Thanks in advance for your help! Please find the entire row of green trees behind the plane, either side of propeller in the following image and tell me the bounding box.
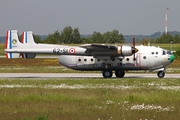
[27,26,180,44]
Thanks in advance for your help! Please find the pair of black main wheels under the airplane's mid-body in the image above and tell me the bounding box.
[102,70,125,78]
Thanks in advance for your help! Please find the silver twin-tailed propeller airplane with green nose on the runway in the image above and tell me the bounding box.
[4,30,175,78]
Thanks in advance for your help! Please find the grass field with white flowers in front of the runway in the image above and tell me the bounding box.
[0,78,180,120]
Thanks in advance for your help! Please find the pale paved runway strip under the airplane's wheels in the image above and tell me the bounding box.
[0,73,180,79]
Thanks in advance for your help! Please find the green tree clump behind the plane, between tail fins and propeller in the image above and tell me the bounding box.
[26,26,125,44]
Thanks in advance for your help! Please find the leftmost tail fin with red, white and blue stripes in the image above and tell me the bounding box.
[5,30,22,59]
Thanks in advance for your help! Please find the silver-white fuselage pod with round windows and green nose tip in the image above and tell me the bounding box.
[59,46,174,71]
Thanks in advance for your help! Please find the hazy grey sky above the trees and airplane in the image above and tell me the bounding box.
[0,0,180,36]
